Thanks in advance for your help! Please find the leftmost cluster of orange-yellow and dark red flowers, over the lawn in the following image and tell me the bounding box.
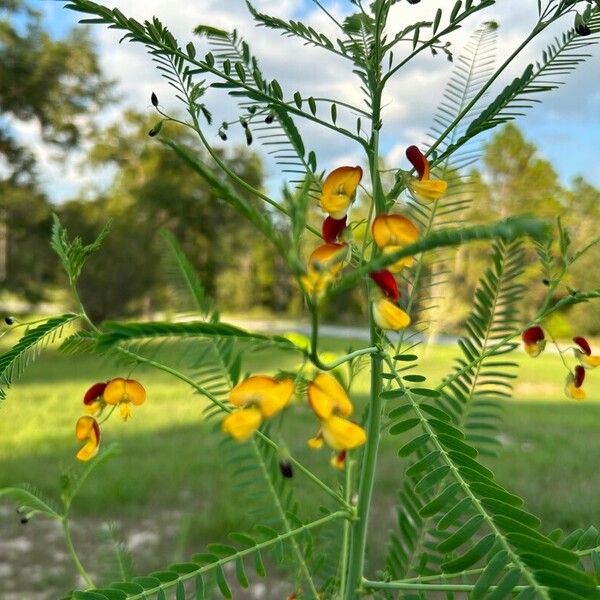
[75,377,146,461]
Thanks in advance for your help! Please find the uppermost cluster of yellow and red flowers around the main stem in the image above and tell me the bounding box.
[300,146,448,331]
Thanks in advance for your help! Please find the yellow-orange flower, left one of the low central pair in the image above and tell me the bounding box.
[222,375,294,442]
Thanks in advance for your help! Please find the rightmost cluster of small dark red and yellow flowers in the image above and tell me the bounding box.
[521,325,600,400]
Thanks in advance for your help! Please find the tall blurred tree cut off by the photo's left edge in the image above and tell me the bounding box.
[0,0,111,301]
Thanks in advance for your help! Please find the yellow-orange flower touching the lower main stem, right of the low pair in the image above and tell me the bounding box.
[308,373,367,468]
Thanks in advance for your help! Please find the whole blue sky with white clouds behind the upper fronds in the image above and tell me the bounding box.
[12,0,600,202]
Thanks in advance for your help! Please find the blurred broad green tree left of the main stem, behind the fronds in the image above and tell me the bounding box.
[60,112,293,317]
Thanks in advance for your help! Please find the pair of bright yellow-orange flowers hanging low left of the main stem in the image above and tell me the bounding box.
[222,373,367,468]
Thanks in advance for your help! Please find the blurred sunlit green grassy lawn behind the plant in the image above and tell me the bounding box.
[0,341,600,600]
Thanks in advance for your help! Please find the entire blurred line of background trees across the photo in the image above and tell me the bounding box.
[0,0,600,335]
